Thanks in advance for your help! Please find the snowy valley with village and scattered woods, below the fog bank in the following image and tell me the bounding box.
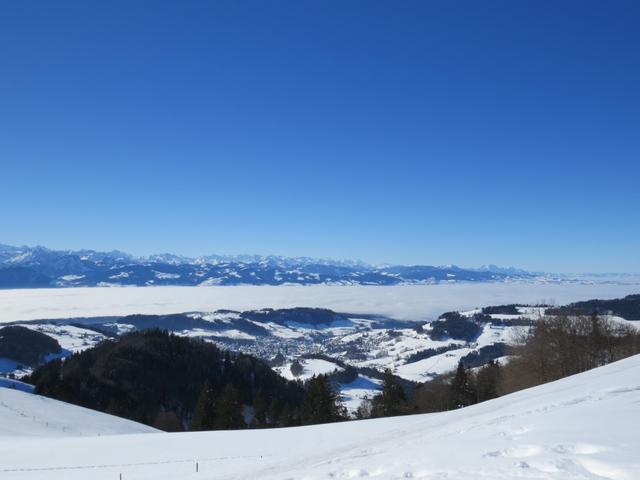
[0,296,640,412]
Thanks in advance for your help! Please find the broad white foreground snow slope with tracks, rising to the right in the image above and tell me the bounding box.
[0,356,640,480]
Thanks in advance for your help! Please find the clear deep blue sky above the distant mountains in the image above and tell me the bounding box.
[0,0,640,272]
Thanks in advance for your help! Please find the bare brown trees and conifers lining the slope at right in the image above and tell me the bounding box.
[357,315,640,418]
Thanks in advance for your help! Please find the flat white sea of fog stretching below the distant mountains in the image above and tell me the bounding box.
[0,282,640,322]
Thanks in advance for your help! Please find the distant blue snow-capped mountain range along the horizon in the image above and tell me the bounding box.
[0,245,539,288]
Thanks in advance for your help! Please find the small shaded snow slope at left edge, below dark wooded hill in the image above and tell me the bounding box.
[0,388,157,436]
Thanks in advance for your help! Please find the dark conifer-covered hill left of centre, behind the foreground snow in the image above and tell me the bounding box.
[28,330,347,431]
